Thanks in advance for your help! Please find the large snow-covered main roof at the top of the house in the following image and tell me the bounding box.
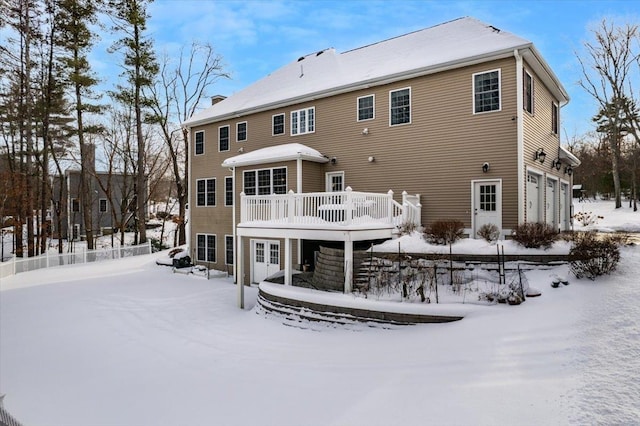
[183,17,568,127]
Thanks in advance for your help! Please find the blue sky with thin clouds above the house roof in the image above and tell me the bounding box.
[110,0,640,139]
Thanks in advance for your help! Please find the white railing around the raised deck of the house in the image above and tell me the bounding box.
[240,187,420,228]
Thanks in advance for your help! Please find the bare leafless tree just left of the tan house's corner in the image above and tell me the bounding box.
[149,42,229,245]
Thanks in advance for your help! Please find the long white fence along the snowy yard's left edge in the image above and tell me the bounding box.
[0,242,151,278]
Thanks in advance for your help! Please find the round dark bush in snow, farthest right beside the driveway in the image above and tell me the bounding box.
[569,232,621,280]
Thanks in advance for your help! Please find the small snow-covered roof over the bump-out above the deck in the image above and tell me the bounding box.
[222,143,329,167]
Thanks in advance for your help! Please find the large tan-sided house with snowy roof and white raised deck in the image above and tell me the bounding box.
[184,17,580,305]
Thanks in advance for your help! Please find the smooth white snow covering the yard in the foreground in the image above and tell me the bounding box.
[0,202,640,426]
